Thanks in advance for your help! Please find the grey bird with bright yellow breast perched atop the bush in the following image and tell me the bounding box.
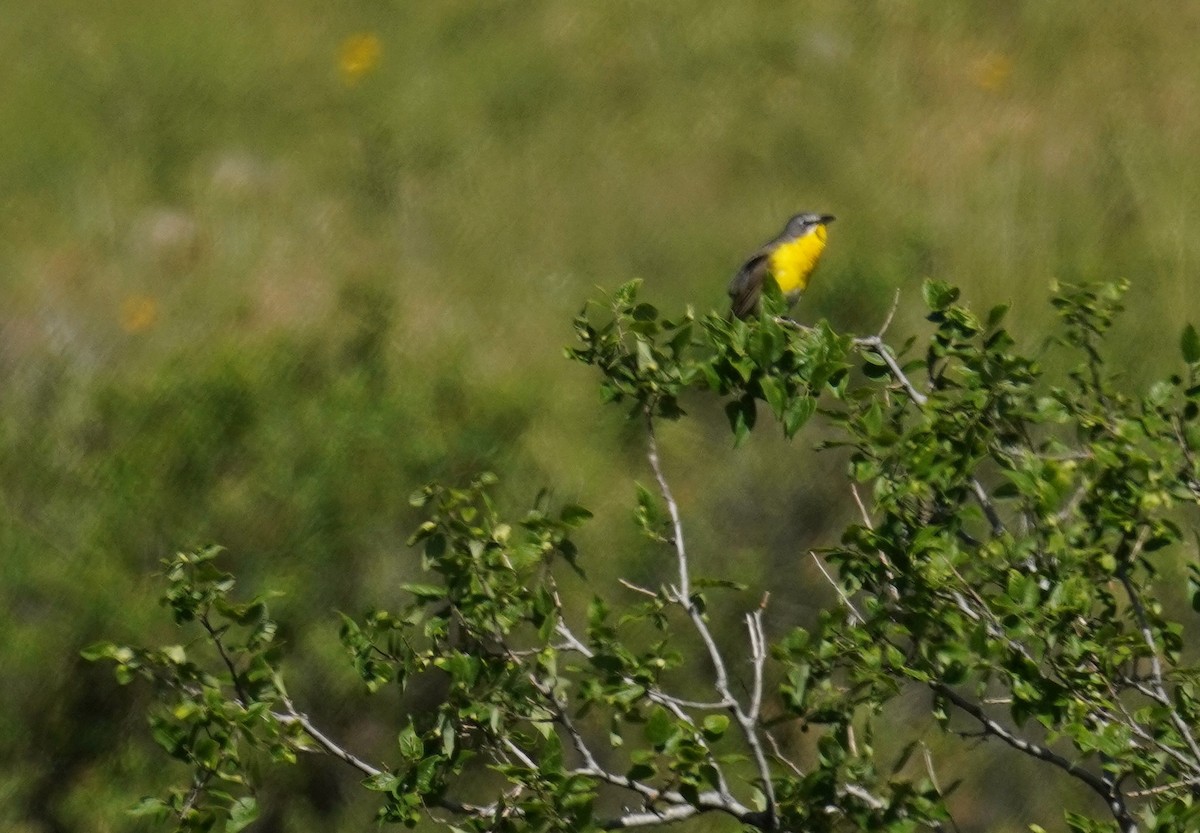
[730,214,834,318]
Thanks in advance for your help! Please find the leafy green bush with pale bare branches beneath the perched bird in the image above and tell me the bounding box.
[85,282,1200,833]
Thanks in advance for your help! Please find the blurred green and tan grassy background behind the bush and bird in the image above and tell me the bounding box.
[0,0,1200,833]
